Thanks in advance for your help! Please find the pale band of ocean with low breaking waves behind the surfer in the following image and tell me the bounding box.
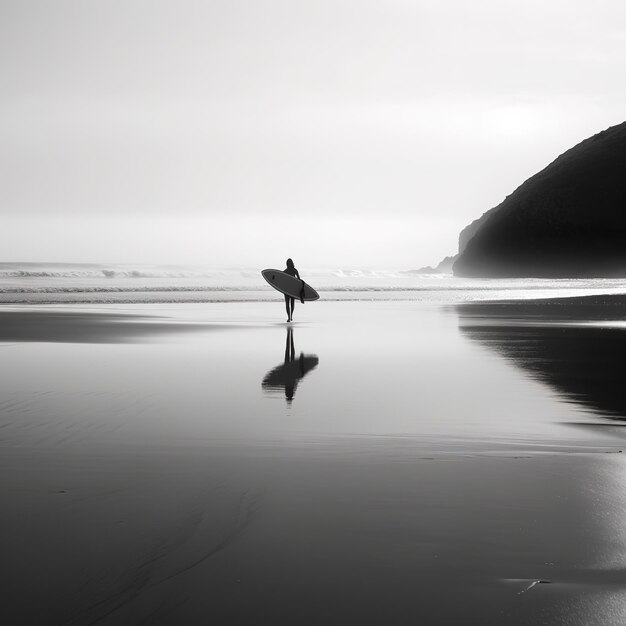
[0,263,626,304]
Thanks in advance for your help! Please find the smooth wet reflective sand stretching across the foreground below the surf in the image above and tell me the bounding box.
[0,297,626,625]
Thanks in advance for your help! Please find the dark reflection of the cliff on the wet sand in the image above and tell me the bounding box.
[456,296,626,420]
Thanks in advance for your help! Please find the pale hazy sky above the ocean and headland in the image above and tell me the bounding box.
[0,0,626,267]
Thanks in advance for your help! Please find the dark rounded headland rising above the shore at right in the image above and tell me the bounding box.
[453,122,626,278]
